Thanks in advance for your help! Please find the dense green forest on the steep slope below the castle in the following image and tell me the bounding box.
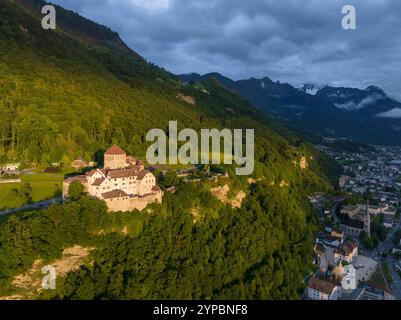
[0,178,324,299]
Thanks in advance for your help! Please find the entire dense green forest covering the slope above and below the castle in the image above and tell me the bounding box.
[0,0,338,299]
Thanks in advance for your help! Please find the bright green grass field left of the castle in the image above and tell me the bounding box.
[0,174,63,210]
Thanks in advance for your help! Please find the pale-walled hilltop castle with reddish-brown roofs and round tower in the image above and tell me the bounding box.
[63,145,163,212]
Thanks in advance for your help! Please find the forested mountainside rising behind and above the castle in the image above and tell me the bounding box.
[0,1,282,163]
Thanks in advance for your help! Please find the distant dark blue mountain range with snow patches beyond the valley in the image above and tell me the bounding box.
[180,73,401,145]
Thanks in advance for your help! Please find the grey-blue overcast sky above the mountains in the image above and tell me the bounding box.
[51,0,401,100]
